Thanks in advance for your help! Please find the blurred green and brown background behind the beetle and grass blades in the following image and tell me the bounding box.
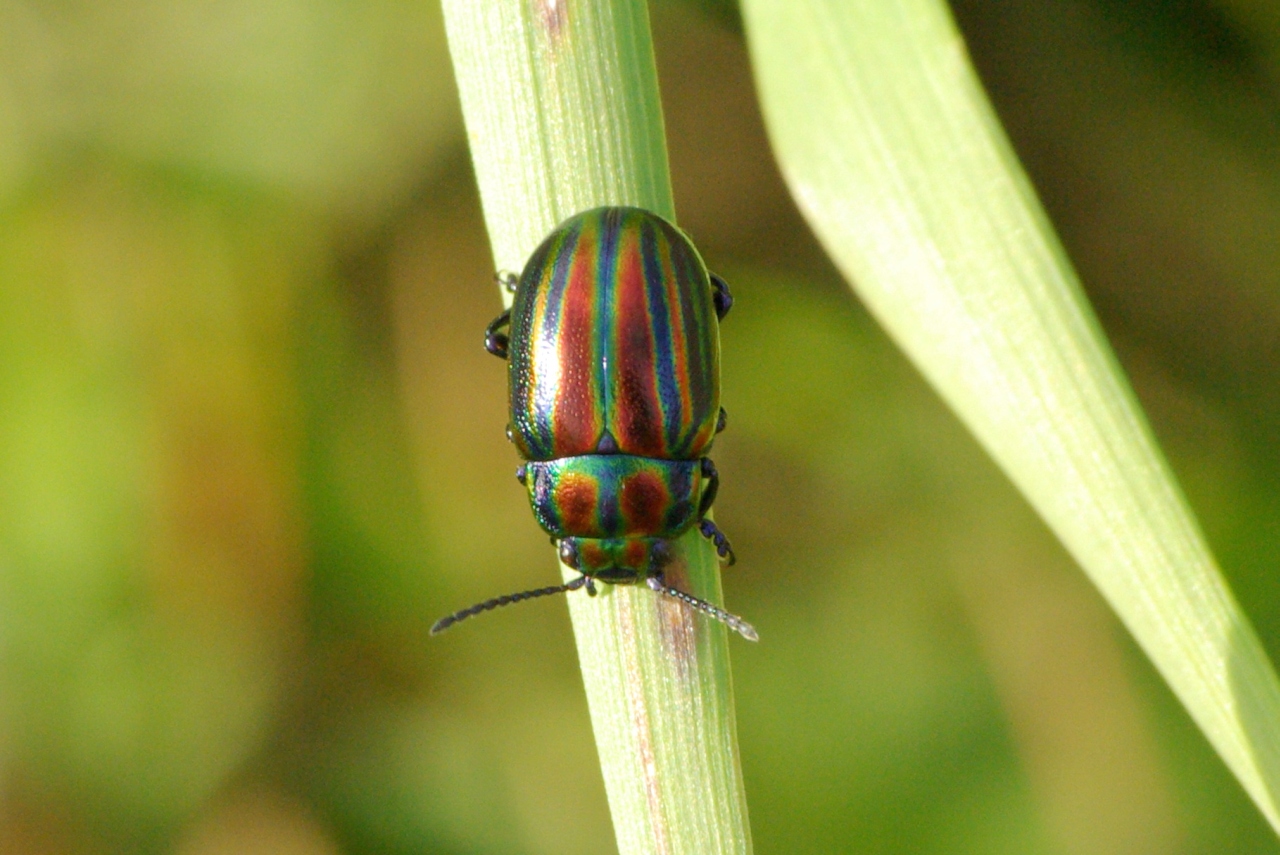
[0,0,1280,855]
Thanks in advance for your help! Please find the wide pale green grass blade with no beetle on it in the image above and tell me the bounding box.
[742,0,1280,828]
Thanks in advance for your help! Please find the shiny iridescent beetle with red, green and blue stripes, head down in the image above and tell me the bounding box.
[431,207,756,641]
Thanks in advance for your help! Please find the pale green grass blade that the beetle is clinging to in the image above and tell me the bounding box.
[444,0,751,855]
